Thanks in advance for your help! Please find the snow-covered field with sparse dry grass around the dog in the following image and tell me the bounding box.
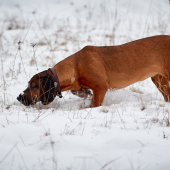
[0,0,170,170]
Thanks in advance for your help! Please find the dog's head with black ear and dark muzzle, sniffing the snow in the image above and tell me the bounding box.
[17,70,62,106]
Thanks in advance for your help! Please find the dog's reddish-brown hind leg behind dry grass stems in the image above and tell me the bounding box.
[151,74,170,102]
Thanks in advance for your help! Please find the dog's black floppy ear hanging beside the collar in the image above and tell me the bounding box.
[41,73,57,105]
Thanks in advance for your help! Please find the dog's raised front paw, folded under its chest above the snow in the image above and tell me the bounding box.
[71,88,92,98]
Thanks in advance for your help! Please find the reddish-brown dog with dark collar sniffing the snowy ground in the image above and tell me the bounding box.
[17,35,170,107]
